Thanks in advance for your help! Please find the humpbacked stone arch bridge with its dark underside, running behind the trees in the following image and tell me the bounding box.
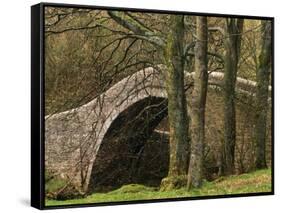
[45,67,271,192]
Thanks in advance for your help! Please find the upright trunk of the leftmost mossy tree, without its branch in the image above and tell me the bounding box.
[162,15,189,188]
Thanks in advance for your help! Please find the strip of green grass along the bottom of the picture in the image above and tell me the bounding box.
[46,169,271,206]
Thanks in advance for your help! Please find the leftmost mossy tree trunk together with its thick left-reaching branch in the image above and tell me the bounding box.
[108,11,190,188]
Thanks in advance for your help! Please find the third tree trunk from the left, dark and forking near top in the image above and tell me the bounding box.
[223,18,243,174]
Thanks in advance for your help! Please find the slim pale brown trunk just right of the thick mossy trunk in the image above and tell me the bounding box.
[187,16,208,188]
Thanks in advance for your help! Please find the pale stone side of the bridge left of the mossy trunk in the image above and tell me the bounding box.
[45,68,166,191]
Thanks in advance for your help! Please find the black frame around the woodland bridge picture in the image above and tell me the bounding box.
[31,3,275,209]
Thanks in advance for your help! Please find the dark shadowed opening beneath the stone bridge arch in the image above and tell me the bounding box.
[88,96,169,192]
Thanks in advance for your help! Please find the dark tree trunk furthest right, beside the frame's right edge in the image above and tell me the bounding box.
[255,21,271,169]
